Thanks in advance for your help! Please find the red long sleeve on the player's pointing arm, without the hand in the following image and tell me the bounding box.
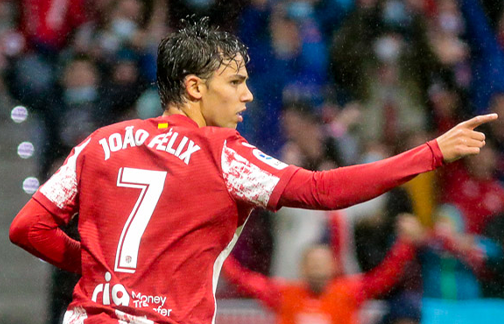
[278,140,443,210]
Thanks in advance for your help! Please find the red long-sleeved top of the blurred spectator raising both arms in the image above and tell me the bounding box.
[223,242,414,324]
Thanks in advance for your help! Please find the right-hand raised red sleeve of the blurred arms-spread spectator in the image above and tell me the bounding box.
[362,241,415,300]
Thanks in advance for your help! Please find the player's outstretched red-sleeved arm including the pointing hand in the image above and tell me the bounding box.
[277,114,497,209]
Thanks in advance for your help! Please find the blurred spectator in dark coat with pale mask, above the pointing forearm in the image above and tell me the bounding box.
[330,1,437,144]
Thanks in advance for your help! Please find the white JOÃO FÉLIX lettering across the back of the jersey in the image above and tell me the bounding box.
[98,126,200,164]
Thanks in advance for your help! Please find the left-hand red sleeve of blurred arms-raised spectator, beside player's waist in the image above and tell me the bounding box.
[222,256,282,311]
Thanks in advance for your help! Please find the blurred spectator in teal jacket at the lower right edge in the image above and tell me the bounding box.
[418,205,504,300]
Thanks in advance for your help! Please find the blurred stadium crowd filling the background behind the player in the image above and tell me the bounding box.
[0,0,504,323]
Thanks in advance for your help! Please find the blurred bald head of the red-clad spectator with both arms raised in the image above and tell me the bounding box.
[301,245,339,294]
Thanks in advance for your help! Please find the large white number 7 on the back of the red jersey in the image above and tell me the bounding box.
[114,168,167,273]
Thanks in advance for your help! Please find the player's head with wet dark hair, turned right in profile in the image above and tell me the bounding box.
[157,18,253,128]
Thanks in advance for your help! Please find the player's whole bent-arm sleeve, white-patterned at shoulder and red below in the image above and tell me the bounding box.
[9,138,91,273]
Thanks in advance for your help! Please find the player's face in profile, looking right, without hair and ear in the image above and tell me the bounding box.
[197,55,254,129]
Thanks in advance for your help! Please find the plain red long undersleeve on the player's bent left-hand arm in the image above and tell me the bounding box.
[9,199,81,273]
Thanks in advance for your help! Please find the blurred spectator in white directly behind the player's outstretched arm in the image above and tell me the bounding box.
[271,101,366,279]
